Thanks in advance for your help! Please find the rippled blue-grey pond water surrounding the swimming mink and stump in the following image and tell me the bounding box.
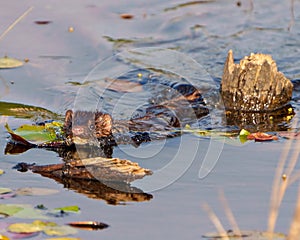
[0,0,300,239]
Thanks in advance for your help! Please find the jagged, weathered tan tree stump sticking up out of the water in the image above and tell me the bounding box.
[221,50,293,112]
